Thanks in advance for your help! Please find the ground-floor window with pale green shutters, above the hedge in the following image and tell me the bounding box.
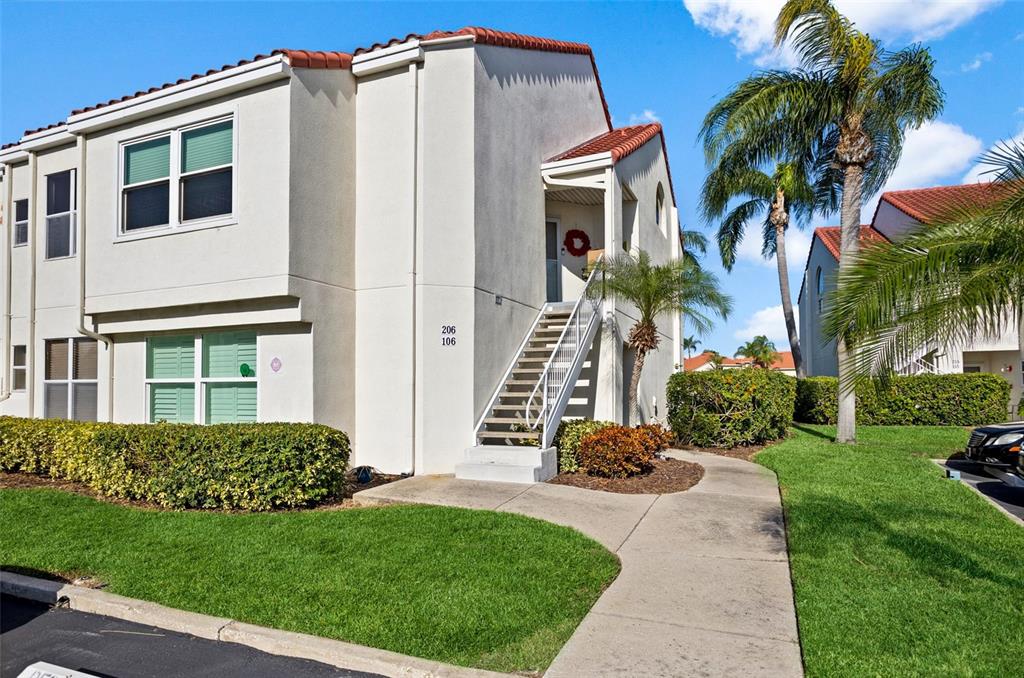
[145,331,259,424]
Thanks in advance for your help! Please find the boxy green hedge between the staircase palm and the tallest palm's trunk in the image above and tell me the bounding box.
[667,368,797,448]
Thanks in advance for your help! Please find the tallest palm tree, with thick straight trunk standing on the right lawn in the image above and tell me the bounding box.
[701,0,943,442]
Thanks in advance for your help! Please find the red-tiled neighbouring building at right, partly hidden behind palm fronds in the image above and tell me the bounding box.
[799,183,1024,407]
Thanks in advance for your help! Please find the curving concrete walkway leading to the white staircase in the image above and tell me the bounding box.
[355,451,803,678]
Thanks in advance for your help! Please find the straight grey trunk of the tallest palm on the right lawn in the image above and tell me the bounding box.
[836,164,864,442]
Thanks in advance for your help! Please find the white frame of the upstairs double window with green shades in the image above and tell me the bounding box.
[114,113,239,242]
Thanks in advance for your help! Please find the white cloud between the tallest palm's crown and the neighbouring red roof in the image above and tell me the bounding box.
[861,122,983,222]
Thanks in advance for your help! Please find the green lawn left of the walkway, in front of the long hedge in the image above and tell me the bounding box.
[0,489,618,671]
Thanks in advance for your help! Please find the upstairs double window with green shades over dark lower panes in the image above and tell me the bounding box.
[120,119,234,235]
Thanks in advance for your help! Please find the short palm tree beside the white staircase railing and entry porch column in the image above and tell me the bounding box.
[599,250,732,424]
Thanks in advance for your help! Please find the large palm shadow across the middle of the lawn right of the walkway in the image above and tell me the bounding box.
[787,495,1020,589]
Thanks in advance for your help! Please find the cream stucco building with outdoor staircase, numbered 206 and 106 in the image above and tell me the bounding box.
[0,29,680,483]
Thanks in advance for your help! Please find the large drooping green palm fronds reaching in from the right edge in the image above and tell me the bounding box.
[824,141,1024,391]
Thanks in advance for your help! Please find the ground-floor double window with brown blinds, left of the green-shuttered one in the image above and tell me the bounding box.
[43,338,97,421]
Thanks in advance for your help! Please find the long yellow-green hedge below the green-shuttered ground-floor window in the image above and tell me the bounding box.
[0,417,349,511]
